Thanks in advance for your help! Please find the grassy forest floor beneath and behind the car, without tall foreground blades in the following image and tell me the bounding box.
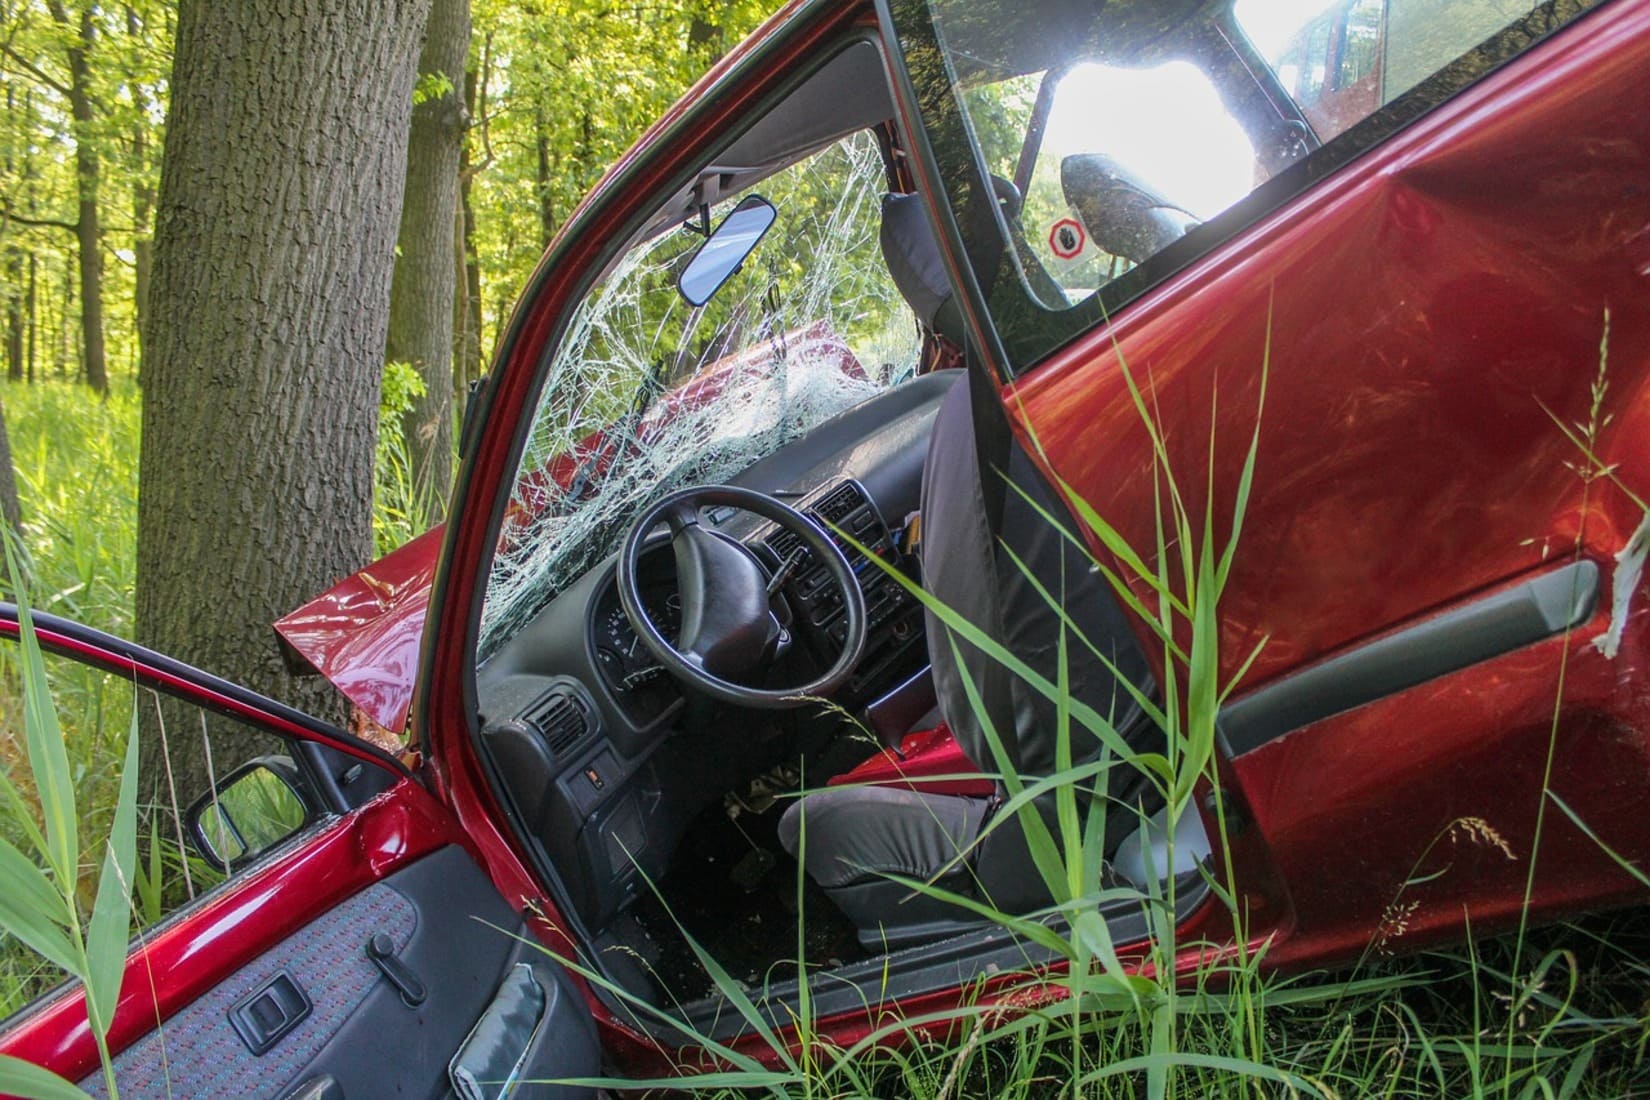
[0,374,1650,1100]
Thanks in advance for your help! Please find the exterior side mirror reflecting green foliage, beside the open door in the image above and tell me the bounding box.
[183,757,310,871]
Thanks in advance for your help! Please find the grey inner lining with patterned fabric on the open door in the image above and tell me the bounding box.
[81,846,599,1100]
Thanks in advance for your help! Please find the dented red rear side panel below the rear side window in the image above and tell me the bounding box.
[1008,5,1650,963]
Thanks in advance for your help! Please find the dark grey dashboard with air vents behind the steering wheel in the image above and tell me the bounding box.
[475,371,960,930]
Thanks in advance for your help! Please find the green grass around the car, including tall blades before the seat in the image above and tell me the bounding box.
[0,341,1650,1100]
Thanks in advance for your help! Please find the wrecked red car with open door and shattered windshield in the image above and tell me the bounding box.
[0,0,1650,1097]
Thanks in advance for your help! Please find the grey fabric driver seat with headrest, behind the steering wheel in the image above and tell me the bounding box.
[779,191,1160,950]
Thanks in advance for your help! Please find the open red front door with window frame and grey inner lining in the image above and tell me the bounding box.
[0,605,601,1097]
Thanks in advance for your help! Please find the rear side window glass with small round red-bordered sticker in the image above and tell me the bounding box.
[889,0,1592,369]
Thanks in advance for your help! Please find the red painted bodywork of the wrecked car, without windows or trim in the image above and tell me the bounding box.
[0,0,1650,1077]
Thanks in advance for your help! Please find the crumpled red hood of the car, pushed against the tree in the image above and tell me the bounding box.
[276,325,865,732]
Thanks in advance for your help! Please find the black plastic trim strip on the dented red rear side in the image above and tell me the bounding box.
[1219,561,1599,755]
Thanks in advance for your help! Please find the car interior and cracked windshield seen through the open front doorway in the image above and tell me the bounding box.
[475,25,1240,1022]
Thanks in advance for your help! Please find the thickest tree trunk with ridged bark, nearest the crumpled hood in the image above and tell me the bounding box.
[137,0,427,798]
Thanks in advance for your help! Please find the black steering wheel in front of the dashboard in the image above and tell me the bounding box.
[617,485,866,709]
